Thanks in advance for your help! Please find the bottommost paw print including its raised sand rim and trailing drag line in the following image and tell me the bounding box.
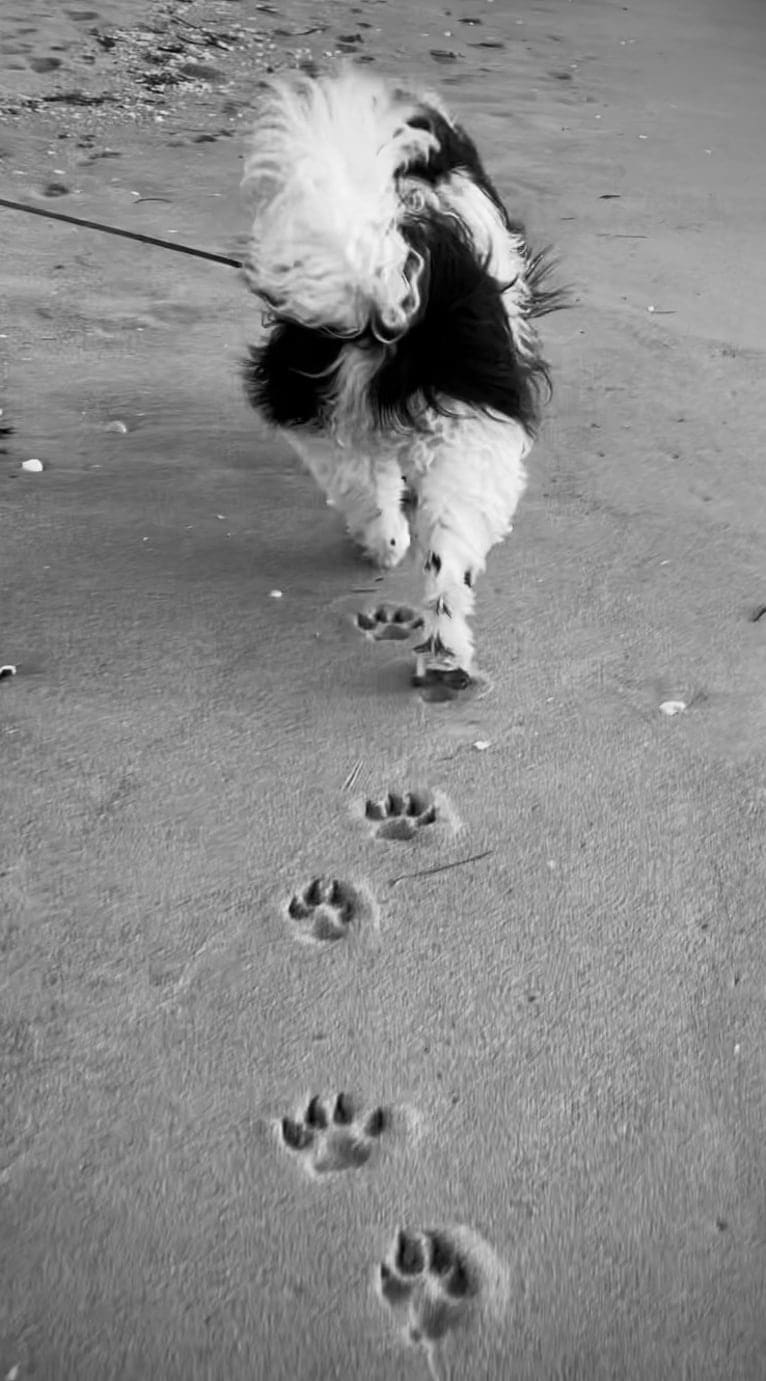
[375,1226,509,1381]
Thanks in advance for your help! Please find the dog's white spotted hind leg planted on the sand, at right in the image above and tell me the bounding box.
[415,417,530,686]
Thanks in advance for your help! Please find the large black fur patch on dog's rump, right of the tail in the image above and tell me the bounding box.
[373,214,547,431]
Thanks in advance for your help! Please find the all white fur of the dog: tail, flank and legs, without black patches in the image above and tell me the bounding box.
[243,69,549,674]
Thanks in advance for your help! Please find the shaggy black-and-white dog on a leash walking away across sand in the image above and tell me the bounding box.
[242,68,563,688]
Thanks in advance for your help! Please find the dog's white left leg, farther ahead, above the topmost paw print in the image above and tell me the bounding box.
[284,431,410,568]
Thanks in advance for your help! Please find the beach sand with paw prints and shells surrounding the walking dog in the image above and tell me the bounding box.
[0,0,766,1381]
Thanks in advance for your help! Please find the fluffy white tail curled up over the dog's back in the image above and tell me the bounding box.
[243,69,447,340]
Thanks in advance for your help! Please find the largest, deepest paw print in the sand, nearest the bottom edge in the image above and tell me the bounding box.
[378,1228,480,1346]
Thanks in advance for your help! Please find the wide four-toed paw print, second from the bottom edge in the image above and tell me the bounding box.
[279,1094,389,1175]
